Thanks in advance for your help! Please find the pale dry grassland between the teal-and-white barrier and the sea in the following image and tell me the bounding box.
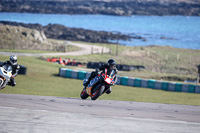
[54,42,200,82]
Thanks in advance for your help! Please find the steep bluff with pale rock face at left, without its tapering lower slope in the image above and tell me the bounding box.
[0,25,49,50]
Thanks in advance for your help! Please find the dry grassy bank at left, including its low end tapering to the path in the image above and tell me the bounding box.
[0,25,80,52]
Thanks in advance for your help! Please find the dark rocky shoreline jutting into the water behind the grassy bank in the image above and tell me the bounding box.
[0,21,145,43]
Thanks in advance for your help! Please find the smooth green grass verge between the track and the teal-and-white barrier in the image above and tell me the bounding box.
[0,55,200,106]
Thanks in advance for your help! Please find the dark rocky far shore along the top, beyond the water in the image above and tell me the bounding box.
[0,0,200,16]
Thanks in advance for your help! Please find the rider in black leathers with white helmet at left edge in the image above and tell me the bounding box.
[1,55,20,87]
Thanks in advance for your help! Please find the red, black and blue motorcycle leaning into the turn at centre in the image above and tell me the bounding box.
[80,69,116,100]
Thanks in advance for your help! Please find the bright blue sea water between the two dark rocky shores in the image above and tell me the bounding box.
[0,13,200,49]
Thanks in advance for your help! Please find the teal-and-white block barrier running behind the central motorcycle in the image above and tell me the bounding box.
[59,68,200,93]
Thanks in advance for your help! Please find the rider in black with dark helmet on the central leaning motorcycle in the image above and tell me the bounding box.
[84,59,118,94]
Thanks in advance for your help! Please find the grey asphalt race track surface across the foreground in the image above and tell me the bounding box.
[0,94,200,133]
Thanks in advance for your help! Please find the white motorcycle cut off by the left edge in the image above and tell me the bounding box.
[0,64,12,90]
